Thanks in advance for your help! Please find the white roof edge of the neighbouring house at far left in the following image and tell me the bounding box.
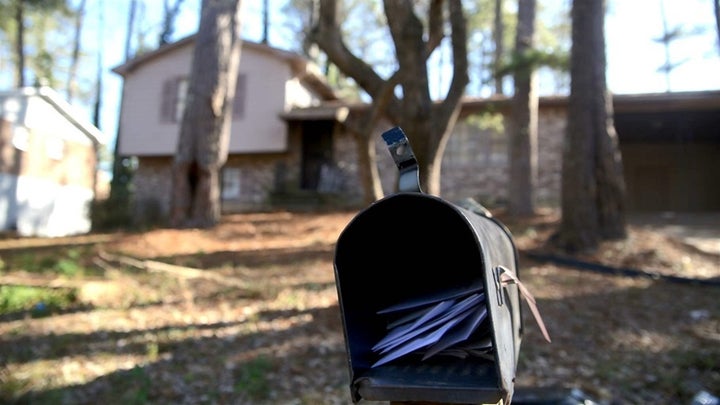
[0,86,107,145]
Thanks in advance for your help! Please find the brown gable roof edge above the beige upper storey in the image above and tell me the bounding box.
[111,34,338,100]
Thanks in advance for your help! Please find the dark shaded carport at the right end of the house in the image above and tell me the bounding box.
[613,91,720,212]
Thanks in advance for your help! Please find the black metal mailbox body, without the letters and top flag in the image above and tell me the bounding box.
[334,192,522,404]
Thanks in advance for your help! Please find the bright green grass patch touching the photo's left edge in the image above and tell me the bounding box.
[0,286,77,317]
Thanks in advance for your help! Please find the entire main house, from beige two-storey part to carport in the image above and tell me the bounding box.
[113,36,720,221]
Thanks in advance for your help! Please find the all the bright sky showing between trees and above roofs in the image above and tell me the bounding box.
[7,0,720,149]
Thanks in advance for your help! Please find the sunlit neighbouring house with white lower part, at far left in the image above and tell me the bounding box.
[0,87,105,237]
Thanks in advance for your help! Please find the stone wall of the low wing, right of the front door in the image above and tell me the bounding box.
[334,106,566,206]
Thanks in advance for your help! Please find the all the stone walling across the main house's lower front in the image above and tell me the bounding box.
[133,103,565,218]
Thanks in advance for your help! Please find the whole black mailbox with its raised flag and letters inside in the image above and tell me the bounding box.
[334,128,522,404]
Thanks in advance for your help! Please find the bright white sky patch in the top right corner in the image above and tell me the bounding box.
[605,0,720,94]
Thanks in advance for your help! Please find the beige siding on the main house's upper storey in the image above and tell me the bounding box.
[119,44,312,156]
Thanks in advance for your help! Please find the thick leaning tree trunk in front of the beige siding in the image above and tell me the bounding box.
[170,0,242,227]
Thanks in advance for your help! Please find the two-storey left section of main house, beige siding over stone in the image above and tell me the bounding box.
[113,35,337,220]
